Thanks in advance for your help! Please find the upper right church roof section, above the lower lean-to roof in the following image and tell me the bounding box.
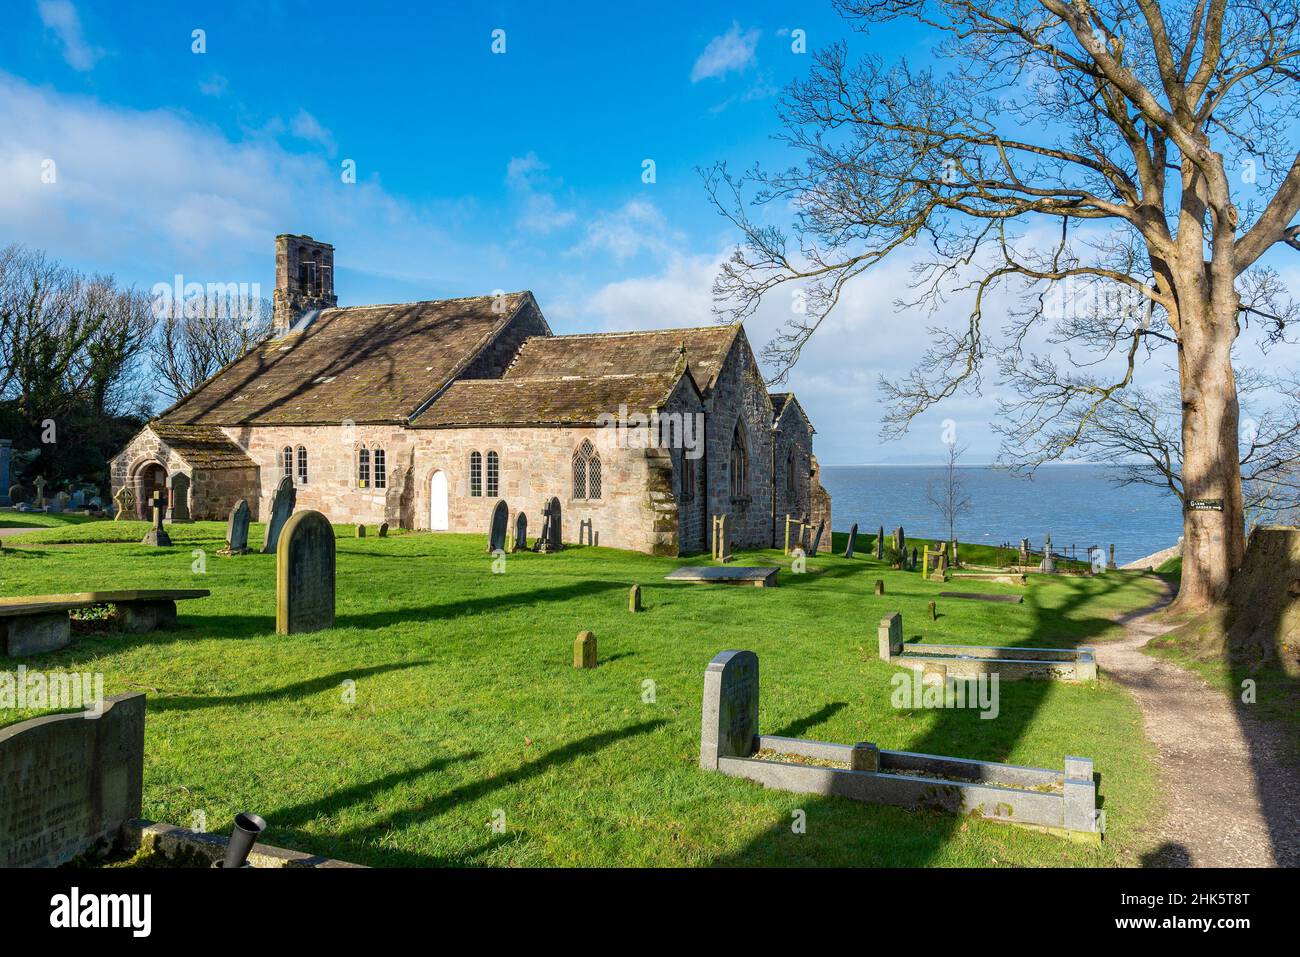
[506,325,740,395]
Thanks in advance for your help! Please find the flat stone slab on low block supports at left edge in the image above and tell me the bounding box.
[0,588,212,658]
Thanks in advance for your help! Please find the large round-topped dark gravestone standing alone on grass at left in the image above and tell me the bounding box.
[276,510,334,635]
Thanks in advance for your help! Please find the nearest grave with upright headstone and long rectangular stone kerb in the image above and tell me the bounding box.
[699,651,1104,841]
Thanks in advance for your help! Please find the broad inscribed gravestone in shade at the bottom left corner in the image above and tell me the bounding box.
[0,692,144,867]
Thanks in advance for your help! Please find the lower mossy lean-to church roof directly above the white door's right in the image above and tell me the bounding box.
[412,371,693,428]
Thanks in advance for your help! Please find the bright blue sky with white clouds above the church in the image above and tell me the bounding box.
[0,0,1294,464]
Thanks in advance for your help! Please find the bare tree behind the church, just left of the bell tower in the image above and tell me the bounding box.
[150,290,272,402]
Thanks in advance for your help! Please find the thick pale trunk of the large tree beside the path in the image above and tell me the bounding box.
[1174,295,1245,611]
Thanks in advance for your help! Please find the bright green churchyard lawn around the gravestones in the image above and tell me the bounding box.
[0,521,1158,866]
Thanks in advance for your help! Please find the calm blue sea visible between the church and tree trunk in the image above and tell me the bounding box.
[822,464,1183,564]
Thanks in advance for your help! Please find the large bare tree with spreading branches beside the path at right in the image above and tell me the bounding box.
[706,0,1300,610]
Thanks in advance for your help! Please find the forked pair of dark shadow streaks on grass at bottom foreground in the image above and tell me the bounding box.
[268,718,668,867]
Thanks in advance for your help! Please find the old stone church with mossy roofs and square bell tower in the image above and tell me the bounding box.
[113,235,831,555]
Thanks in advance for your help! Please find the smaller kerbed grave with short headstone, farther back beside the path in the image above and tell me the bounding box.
[876,611,1097,681]
